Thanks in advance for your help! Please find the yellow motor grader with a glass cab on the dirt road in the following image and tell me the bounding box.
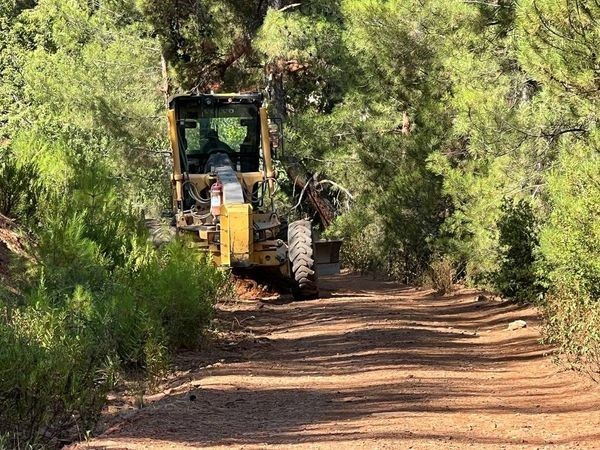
[168,93,339,299]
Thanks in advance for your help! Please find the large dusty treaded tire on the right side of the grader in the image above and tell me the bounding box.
[288,220,319,300]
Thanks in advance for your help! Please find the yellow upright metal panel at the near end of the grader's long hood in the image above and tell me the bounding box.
[220,204,253,266]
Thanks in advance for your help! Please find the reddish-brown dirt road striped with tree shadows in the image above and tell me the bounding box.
[80,275,600,449]
